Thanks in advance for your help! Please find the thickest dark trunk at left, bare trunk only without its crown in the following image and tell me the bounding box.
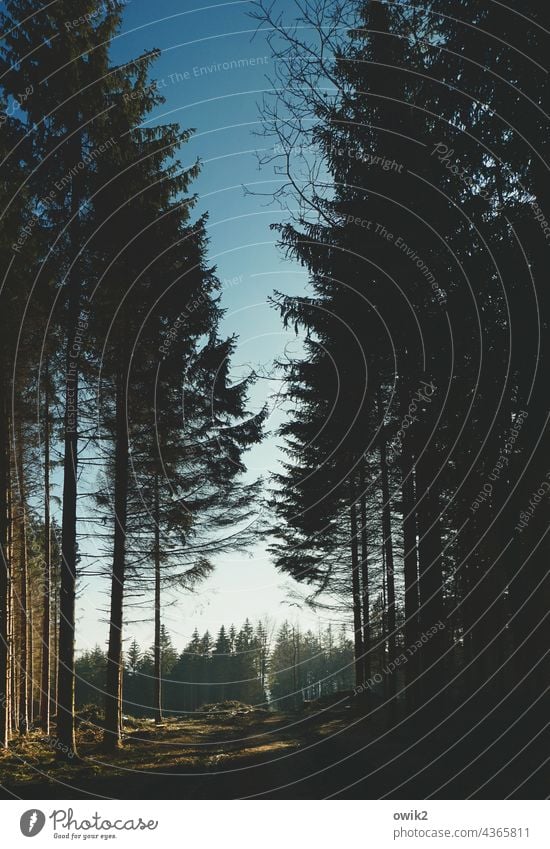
[56,144,82,758]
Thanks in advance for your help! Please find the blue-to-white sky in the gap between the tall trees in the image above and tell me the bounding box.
[73,0,340,652]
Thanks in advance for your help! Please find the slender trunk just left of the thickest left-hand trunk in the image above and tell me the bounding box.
[40,380,52,735]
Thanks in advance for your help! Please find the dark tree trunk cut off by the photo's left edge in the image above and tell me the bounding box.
[0,388,11,749]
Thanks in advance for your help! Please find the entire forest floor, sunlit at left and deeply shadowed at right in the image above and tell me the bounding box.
[0,704,550,799]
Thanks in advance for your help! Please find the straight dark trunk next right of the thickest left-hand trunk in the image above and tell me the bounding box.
[104,369,128,749]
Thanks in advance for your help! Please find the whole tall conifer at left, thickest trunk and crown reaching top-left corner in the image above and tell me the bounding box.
[2,0,131,756]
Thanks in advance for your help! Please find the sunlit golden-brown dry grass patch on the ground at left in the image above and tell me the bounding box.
[0,706,348,788]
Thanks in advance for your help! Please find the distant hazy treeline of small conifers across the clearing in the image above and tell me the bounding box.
[76,619,353,716]
